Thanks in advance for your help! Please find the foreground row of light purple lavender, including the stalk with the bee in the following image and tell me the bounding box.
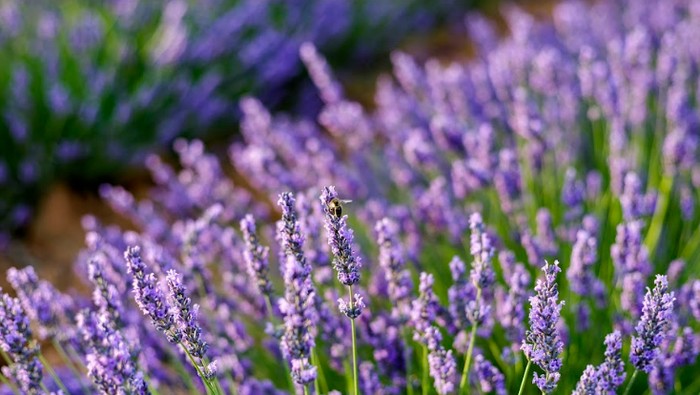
[0,0,700,395]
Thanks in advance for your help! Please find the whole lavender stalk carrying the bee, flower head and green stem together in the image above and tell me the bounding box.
[321,186,365,395]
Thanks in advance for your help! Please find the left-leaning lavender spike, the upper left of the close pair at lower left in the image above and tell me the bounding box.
[124,247,182,343]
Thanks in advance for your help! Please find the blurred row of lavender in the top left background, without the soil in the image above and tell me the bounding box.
[0,0,464,238]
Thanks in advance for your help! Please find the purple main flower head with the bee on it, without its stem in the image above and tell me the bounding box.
[321,186,362,285]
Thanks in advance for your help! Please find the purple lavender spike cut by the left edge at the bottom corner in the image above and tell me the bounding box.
[0,289,43,394]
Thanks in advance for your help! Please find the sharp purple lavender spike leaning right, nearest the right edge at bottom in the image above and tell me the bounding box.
[630,274,676,373]
